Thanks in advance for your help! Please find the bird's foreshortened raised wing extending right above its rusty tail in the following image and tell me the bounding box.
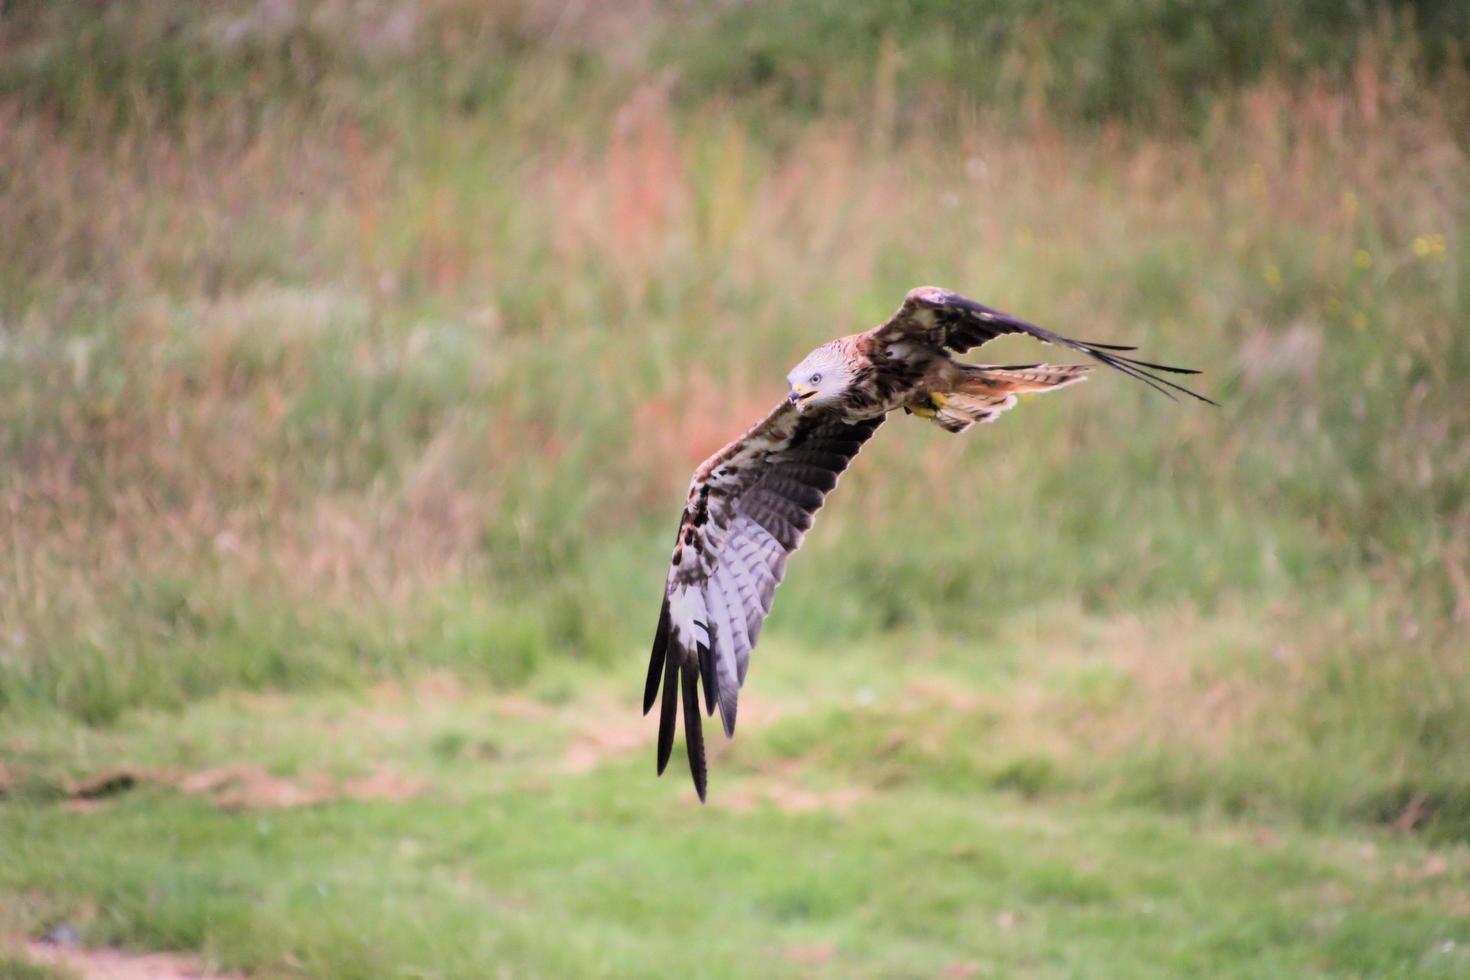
[873,287,1216,406]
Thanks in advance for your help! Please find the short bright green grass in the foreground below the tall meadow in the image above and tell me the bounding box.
[0,648,1470,977]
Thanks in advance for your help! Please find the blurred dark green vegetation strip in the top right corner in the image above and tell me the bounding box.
[663,0,1470,128]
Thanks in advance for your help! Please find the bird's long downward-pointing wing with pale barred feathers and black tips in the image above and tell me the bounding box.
[644,401,882,799]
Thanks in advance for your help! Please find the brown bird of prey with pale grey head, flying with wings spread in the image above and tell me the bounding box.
[644,287,1214,801]
